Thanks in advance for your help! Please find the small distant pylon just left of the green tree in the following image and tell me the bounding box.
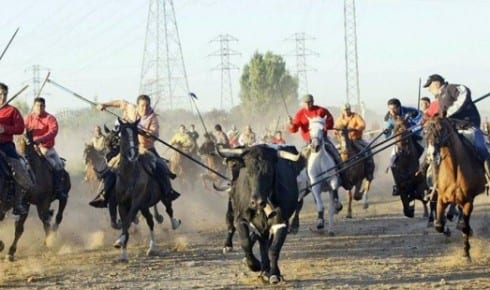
[211,34,240,110]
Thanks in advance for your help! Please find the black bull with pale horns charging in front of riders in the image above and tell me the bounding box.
[219,145,304,283]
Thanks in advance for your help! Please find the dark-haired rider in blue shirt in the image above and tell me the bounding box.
[383,98,424,196]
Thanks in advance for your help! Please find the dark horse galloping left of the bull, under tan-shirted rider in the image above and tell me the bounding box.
[114,120,174,262]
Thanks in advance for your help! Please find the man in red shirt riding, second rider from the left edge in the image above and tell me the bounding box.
[24,97,68,199]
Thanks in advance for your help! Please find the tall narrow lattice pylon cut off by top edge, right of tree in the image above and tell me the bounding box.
[344,0,364,115]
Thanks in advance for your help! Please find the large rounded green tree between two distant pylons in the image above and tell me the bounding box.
[240,51,298,114]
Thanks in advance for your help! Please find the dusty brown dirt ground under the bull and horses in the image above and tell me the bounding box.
[0,174,490,289]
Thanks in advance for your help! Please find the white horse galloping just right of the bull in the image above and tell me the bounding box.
[306,117,340,235]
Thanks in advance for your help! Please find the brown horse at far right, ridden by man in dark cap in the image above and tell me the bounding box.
[424,118,486,261]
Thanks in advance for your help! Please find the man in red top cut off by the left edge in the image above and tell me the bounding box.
[0,83,33,215]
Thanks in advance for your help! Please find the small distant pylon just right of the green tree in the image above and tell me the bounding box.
[286,32,318,95]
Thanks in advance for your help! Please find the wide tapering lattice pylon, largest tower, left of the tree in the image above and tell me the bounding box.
[140,0,192,109]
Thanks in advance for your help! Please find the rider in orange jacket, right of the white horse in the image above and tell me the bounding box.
[334,104,374,187]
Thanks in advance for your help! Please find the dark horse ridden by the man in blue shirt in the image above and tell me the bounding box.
[391,118,429,218]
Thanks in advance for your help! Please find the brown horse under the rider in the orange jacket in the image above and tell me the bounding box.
[337,128,374,218]
